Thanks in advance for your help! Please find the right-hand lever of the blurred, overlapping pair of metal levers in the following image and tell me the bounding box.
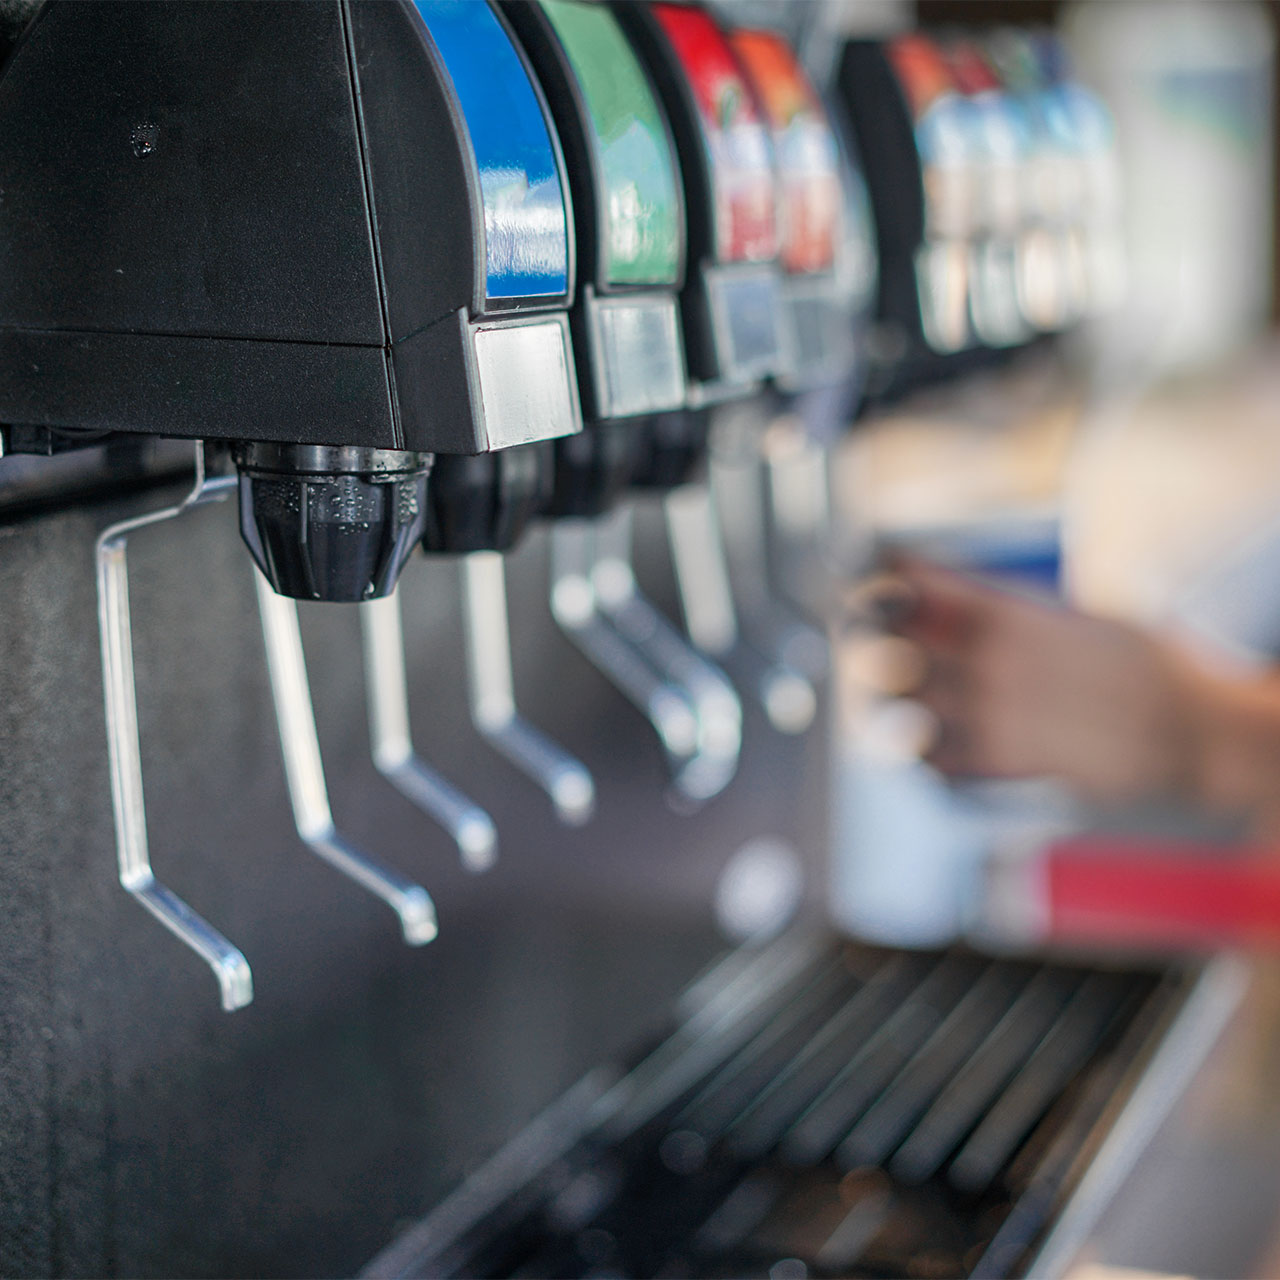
[590,507,742,801]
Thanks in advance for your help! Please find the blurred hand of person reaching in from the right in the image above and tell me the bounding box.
[860,561,1207,801]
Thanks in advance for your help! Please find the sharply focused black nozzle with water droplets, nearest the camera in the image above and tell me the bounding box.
[236,440,431,603]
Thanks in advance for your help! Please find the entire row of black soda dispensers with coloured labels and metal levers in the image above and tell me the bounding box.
[0,0,1120,1010]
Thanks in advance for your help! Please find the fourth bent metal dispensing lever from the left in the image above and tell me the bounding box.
[462,552,595,826]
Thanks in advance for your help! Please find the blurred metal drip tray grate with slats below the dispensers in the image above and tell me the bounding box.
[366,940,1194,1280]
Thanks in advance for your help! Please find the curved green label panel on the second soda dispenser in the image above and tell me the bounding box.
[541,0,682,284]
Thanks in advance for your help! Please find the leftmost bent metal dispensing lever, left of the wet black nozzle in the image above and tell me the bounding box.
[96,440,253,1012]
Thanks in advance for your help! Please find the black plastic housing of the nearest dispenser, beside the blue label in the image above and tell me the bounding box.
[0,0,567,453]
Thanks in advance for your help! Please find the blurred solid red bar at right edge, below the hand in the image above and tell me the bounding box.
[1041,838,1280,947]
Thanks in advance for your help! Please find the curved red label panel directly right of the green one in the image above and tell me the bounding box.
[653,4,778,262]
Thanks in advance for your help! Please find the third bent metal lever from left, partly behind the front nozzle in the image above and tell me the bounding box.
[360,591,498,872]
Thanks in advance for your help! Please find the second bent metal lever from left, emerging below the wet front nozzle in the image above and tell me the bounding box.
[253,571,436,946]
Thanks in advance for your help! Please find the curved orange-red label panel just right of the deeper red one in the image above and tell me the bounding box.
[730,31,844,273]
